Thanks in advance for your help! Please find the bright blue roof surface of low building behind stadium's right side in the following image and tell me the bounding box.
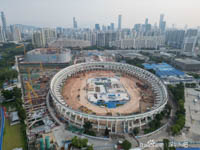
[143,63,185,77]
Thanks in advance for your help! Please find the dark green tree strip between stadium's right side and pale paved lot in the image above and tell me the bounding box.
[168,83,185,135]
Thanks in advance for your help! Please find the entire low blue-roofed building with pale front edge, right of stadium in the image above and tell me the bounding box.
[143,62,195,84]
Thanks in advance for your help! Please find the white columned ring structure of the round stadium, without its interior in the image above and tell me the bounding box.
[49,62,168,133]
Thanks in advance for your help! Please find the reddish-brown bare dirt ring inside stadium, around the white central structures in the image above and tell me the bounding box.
[62,71,153,116]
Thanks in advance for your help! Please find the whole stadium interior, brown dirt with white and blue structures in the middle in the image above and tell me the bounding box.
[62,71,154,116]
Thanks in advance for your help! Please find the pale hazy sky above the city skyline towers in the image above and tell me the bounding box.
[0,0,200,27]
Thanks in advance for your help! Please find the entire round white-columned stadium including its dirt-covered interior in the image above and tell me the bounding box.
[49,62,168,133]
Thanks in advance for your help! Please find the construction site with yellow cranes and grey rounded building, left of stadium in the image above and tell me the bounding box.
[17,48,71,148]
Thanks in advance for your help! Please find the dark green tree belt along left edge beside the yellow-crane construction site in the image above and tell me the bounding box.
[0,43,33,148]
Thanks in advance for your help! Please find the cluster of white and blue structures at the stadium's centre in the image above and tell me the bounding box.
[86,76,130,108]
